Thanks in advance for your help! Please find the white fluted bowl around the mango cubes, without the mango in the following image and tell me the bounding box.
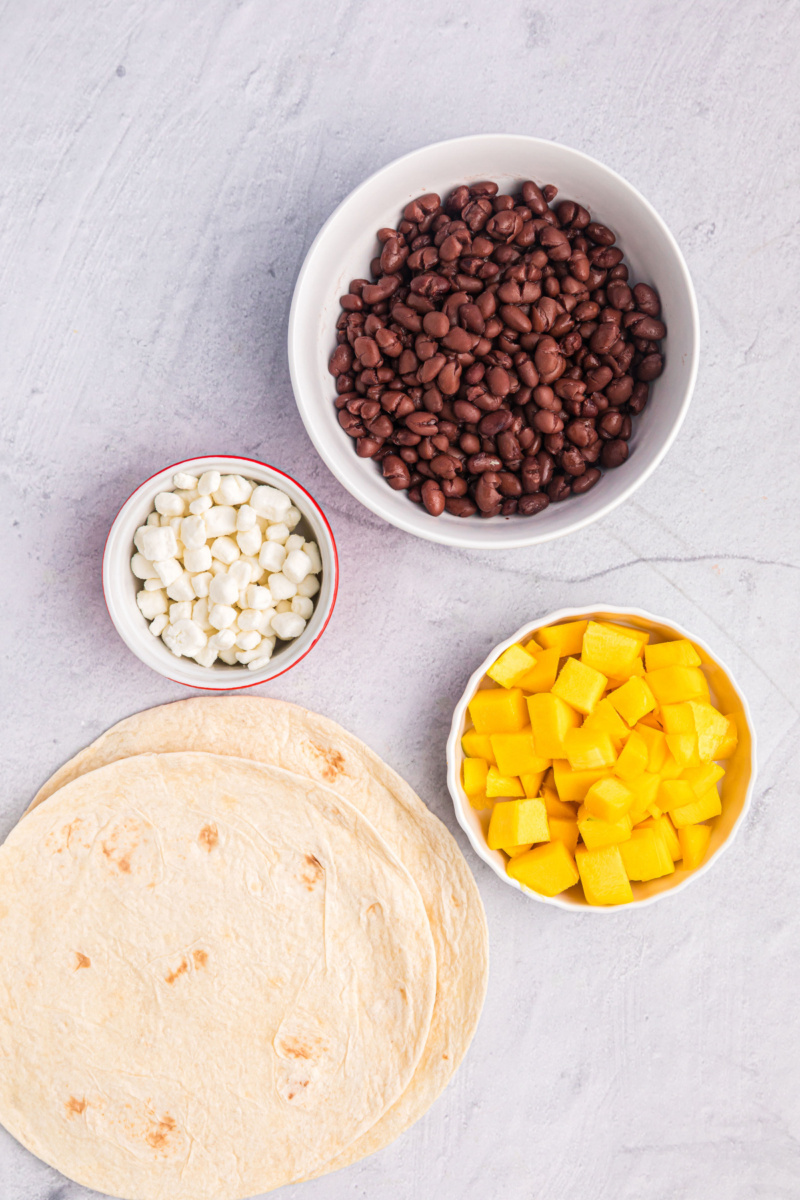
[447,605,756,913]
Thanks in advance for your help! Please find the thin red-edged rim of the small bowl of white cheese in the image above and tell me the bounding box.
[102,454,339,691]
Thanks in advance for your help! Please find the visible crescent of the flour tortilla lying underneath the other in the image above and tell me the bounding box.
[31,696,488,1170]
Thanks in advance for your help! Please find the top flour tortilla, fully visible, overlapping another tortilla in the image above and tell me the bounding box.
[0,754,435,1200]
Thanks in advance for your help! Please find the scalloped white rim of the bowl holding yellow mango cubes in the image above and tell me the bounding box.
[446,604,758,916]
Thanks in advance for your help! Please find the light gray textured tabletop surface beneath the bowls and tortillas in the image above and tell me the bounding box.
[0,0,800,1200]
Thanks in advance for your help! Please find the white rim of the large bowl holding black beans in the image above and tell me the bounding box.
[288,133,700,551]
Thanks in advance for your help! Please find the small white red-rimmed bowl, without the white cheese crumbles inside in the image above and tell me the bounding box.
[103,455,339,691]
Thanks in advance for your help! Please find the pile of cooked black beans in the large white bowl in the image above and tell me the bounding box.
[330,180,667,517]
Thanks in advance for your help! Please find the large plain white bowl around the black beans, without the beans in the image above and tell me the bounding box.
[289,133,699,550]
